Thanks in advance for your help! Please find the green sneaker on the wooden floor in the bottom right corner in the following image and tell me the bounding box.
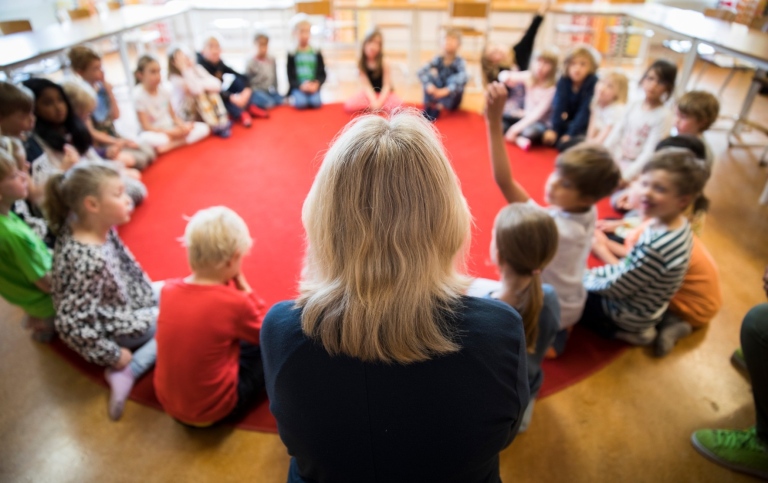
[691,427,768,479]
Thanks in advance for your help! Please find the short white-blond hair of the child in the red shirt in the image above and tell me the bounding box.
[184,206,253,271]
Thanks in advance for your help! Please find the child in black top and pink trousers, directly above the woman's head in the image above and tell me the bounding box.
[344,30,403,112]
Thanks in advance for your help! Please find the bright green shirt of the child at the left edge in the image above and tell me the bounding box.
[0,212,56,318]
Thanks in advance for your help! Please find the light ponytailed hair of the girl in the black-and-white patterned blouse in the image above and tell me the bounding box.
[43,161,120,234]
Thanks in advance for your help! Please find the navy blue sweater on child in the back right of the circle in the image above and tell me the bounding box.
[552,74,597,139]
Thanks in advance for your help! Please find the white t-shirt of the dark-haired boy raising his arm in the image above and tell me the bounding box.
[528,199,597,329]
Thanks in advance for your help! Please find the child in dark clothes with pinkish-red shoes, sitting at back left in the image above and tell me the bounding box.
[197,35,269,127]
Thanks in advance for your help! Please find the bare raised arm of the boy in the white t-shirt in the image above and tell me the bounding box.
[485,82,530,203]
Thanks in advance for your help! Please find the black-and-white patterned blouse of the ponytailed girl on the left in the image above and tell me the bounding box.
[52,228,158,366]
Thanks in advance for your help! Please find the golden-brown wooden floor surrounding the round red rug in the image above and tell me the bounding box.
[0,47,768,483]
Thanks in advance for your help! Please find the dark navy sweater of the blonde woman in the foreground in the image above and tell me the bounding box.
[261,297,529,483]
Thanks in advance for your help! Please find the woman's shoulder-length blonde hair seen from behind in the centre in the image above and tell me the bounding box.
[296,110,471,364]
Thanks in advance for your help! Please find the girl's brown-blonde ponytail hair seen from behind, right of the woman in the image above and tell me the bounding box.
[494,203,558,352]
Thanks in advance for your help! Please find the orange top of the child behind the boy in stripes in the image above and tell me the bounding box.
[624,220,723,327]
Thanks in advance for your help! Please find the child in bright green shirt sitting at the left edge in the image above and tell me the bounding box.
[0,142,56,342]
